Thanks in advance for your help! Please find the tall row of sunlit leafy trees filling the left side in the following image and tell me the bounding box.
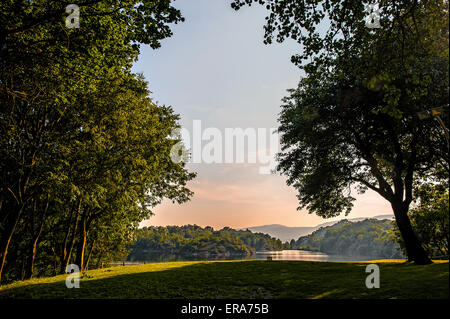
[0,0,195,282]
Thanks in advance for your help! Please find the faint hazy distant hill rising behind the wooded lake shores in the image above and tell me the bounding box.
[241,214,394,242]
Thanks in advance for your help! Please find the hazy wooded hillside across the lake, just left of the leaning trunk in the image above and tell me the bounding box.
[291,219,403,258]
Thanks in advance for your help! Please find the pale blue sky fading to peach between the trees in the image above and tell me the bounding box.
[133,0,392,229]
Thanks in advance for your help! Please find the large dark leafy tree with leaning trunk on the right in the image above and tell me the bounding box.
[233,0,449,264]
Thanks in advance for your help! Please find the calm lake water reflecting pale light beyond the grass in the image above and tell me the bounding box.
[125,250,398,265]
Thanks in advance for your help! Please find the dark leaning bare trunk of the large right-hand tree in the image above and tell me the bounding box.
[391,203,432,265]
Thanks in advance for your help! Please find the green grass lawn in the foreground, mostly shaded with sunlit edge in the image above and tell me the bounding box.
[0,260,449,299]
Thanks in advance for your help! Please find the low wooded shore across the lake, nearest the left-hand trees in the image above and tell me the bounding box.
[128,225,289,260]
